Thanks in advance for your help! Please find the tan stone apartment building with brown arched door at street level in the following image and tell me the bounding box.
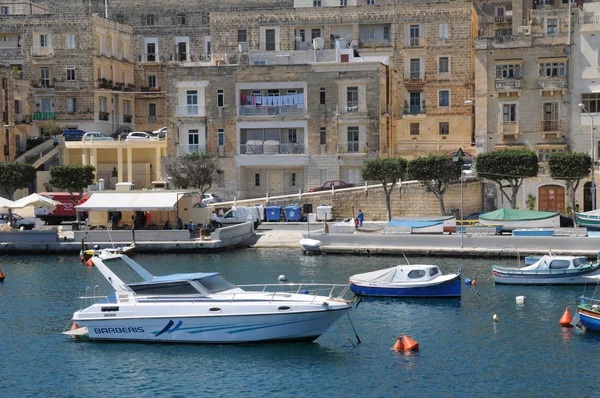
[471,0,572,212]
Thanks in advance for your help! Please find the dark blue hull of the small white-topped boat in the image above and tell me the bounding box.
[350,275,461,297]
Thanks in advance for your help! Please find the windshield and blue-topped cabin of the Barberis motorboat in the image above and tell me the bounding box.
[127,272,243,296]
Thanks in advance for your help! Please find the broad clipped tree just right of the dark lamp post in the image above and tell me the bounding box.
[475,149,538,209]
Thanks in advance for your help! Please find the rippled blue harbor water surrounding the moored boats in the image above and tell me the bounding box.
[0,249,600,397]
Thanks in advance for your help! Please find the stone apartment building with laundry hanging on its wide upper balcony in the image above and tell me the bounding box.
[167,50,392,198]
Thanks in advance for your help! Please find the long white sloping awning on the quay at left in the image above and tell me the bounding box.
[75,191,186,211]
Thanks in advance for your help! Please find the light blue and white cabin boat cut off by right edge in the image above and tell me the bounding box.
[492,253,600,285]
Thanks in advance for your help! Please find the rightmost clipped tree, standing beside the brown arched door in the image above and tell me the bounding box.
[548,152,592,225]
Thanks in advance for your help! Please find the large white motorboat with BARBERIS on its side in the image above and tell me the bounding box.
[63,255,351,343]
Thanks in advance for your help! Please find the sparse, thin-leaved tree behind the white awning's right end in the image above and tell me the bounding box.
[162,153,223,195]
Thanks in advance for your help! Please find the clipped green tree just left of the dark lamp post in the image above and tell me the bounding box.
[408,155,460,216]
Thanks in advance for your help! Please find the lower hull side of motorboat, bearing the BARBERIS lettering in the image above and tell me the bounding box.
[73,305,351,344]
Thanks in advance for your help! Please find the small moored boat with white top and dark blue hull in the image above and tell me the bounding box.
[350,265,461,297]
